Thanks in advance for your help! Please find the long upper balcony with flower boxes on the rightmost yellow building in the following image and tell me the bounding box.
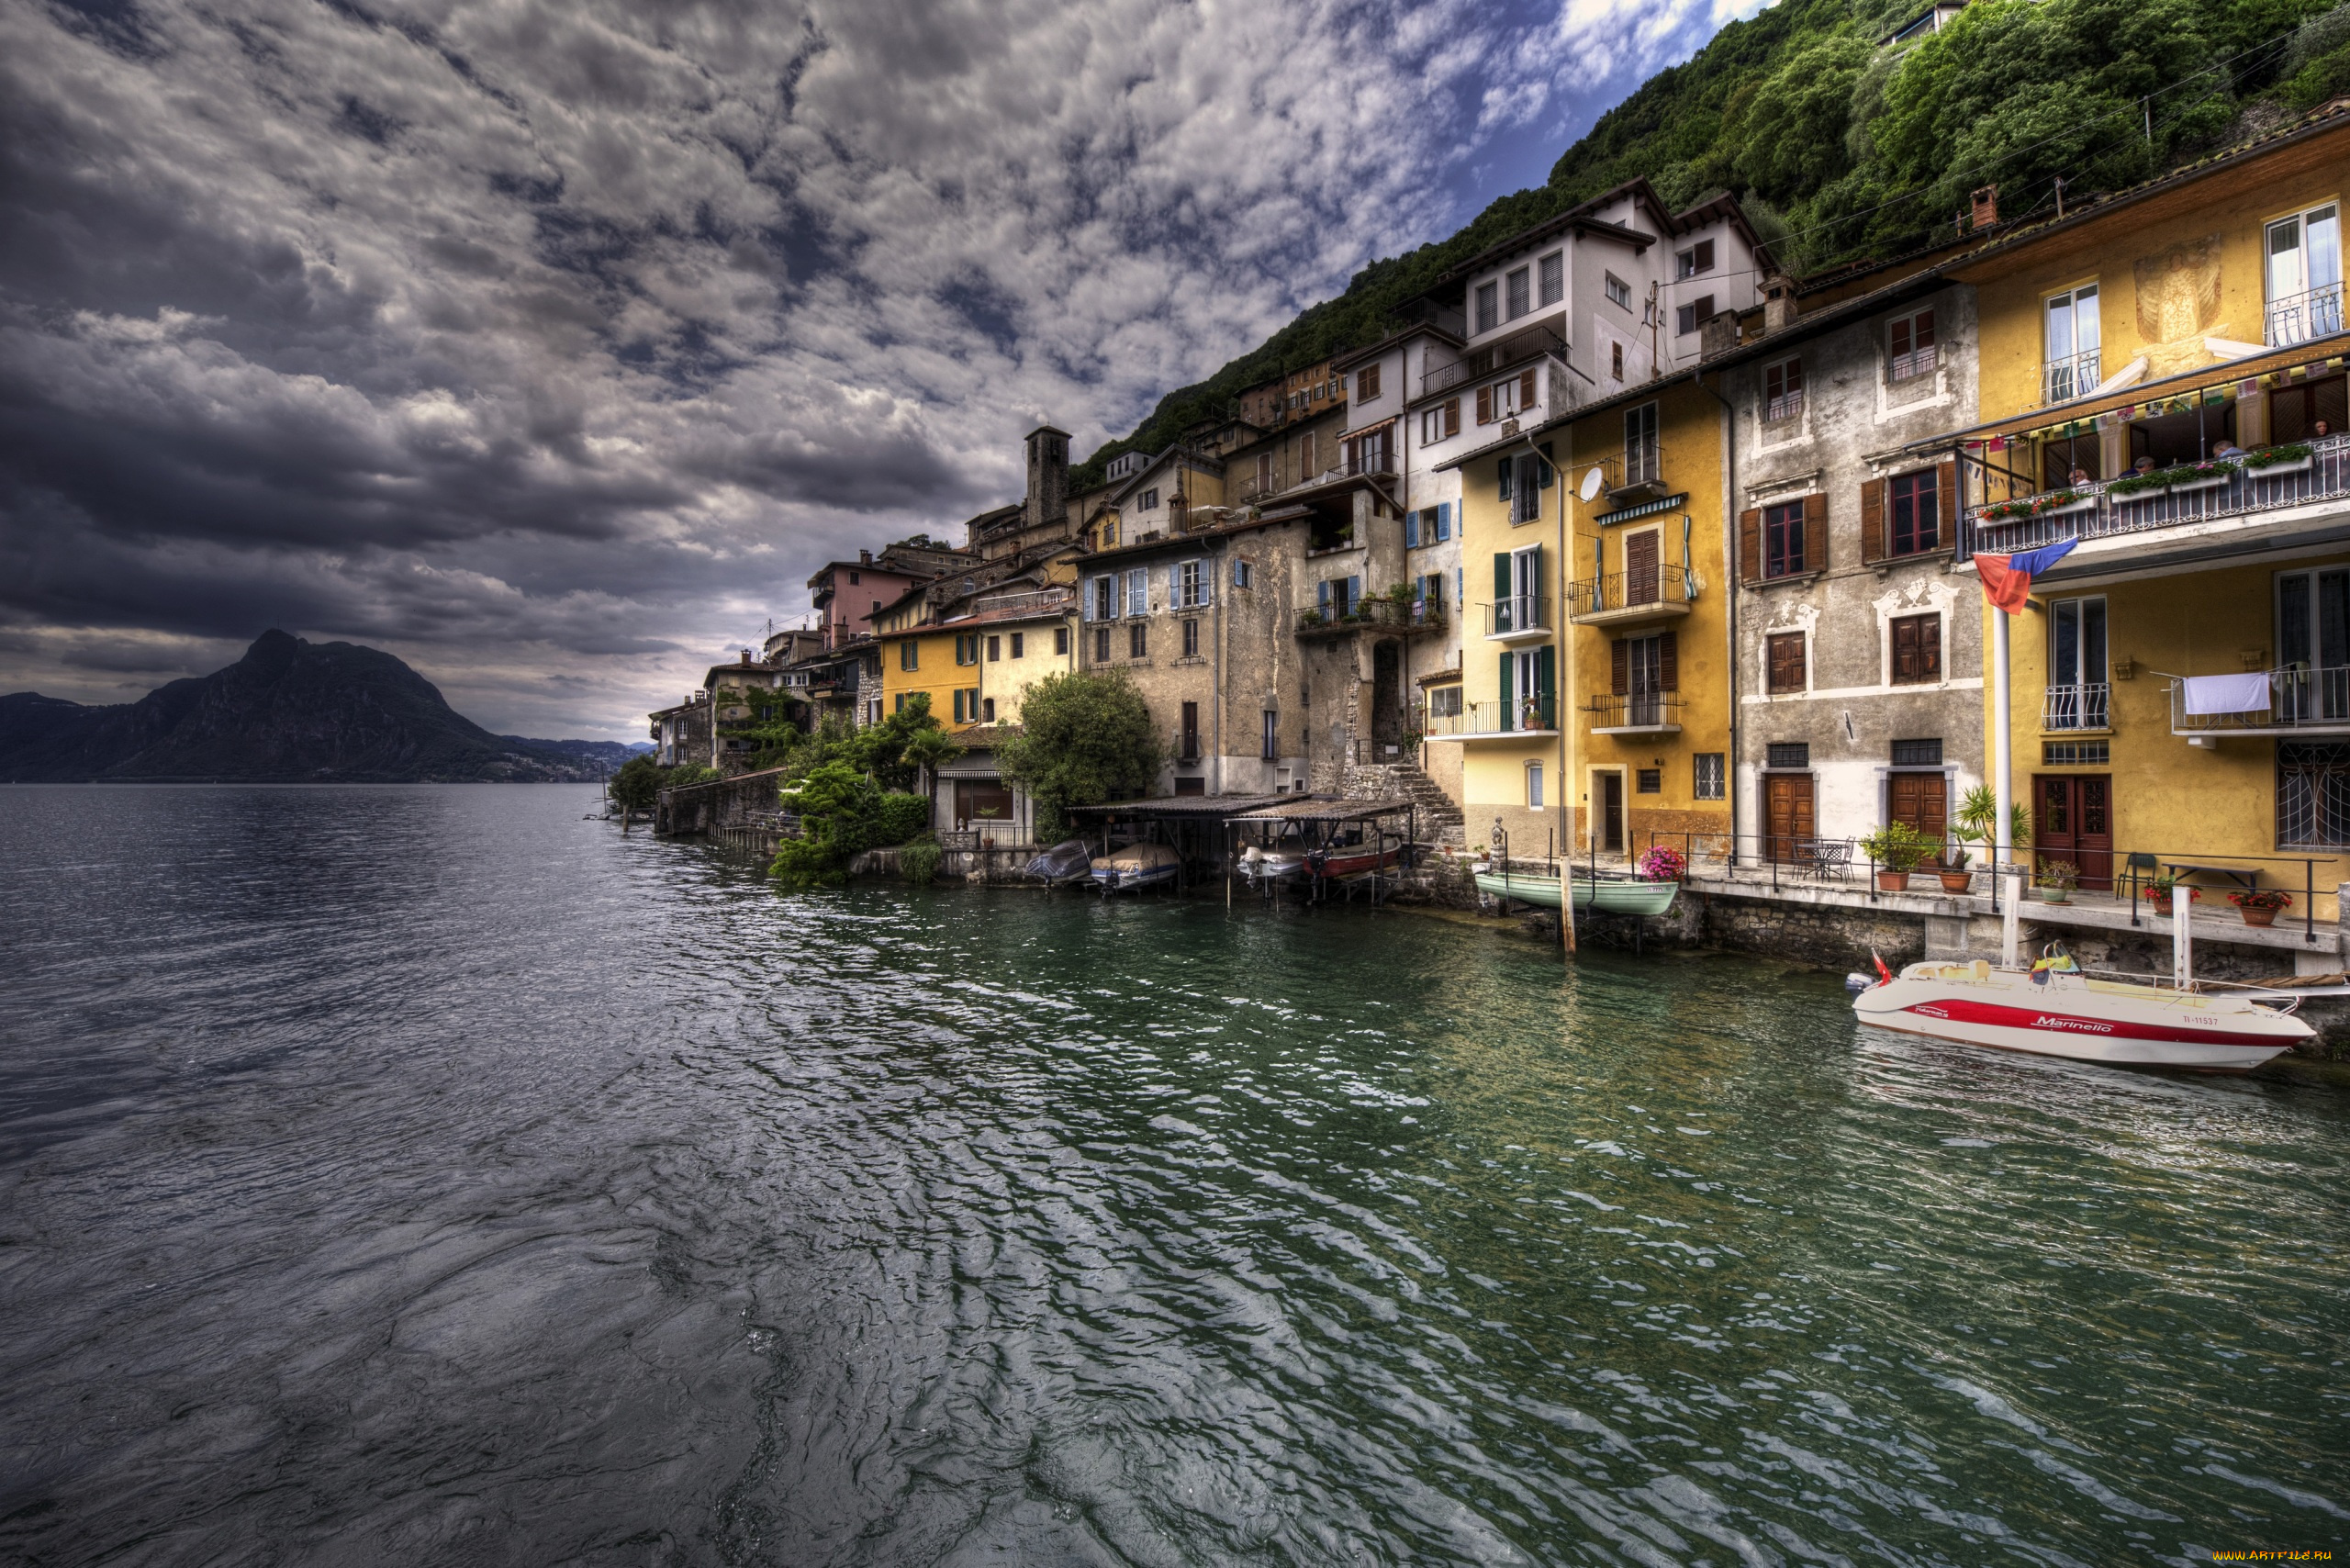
[1960,435,2350,557]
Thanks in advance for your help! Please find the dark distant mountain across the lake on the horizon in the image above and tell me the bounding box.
[0,633,632,783]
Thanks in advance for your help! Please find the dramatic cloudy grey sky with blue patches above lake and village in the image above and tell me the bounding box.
[0,0,1755,738]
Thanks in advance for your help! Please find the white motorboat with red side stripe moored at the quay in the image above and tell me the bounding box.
[1852,959,2315,1072]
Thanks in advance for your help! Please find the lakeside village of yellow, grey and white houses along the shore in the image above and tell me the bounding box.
[630,101,2350,1048]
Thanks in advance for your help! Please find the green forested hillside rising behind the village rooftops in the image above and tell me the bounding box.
[1076,0,2350,485]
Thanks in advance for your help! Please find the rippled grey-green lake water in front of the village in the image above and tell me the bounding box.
[0,788,2350,1565]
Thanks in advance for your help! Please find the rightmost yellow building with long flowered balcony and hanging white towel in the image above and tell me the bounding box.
[1943,106,2350,921]
